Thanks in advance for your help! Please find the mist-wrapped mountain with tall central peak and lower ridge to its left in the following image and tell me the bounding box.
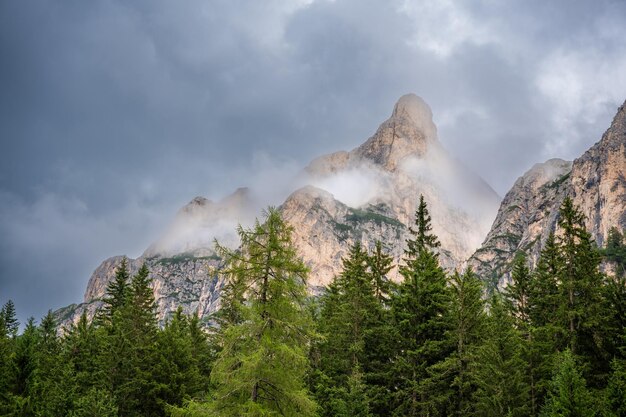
[57,94,500,324]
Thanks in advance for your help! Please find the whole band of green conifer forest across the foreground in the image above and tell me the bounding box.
[0,197,626,417]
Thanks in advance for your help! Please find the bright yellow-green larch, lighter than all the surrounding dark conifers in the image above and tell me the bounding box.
[189,208,316,416]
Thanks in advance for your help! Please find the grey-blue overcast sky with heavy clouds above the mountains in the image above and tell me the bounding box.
[0,0,626,321]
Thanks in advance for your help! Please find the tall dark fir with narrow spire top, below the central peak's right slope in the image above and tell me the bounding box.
[391,196,452,416]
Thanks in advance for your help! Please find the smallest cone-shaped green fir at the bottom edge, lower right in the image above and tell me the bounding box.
[541,349,596,417]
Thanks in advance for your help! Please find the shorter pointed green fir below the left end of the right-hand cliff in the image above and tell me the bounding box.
[471,294,530,417]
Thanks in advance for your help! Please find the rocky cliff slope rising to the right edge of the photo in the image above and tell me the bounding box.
[468,99,626,285]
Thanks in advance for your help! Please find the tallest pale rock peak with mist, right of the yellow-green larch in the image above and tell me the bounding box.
[281,94,500,286]
